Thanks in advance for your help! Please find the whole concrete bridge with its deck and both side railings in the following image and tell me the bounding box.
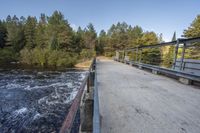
[60,38,200,133]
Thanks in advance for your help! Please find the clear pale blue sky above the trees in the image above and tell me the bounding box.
[0,0,200,41]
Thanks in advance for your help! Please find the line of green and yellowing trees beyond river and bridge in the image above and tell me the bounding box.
[0,11,200,67]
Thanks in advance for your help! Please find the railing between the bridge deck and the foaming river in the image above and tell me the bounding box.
[60,58,100,133]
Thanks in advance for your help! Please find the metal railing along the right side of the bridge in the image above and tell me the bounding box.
[115,37,200,82]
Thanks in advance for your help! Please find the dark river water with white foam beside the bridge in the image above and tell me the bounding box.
[0,69,86,133]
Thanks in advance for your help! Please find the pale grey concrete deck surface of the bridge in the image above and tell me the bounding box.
[97,59,200,133]
